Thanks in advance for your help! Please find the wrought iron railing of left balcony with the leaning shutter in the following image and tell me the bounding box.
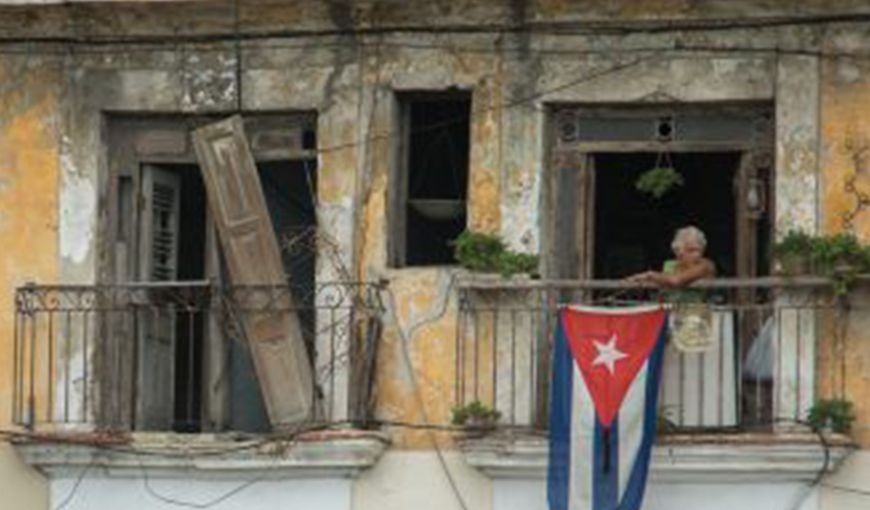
[12,281,382,431]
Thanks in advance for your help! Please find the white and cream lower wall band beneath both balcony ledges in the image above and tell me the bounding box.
[29,447,870,510]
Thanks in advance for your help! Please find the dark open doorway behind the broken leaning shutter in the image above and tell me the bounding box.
[133,160,317,432]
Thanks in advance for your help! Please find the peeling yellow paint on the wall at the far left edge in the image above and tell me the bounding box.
[0,58,59,428]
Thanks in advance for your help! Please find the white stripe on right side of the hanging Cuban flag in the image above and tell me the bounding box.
[617,361,649,501]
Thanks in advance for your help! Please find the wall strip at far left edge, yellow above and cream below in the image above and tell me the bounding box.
[0,55,60,508]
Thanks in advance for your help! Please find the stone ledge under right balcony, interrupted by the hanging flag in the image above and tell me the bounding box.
[460,434,854,483]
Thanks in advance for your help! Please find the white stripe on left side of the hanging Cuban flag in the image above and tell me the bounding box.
[568,362,595,510]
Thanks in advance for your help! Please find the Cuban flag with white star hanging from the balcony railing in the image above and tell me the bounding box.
[547,305,667,510]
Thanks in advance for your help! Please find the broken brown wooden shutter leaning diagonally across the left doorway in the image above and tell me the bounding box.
[193,116,313,427]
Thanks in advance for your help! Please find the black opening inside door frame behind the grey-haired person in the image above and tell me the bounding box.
[592,152,744,278]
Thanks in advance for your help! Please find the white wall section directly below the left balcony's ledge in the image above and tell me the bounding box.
[47,468,352,510]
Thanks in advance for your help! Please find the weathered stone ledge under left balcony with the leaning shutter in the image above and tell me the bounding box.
[15,431,389,479]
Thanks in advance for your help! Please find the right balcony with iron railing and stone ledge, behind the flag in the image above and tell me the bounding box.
[454,278,867,484]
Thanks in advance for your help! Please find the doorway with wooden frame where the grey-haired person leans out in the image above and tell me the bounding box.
[545,104,775,428]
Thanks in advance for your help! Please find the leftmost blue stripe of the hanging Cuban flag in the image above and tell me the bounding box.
[547,320,574,510]
